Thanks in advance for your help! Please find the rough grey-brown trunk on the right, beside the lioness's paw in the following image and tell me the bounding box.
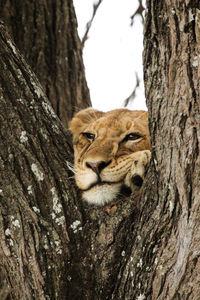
[114,0,200,299]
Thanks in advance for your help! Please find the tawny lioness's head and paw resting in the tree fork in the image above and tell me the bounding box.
[69,108,151,205]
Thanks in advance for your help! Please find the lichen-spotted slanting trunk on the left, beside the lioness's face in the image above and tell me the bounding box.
[0,25,76,299]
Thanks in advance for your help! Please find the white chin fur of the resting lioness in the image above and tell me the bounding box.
[82,183,121,206]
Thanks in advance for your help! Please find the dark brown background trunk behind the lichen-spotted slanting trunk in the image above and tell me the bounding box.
[0,0,91,127]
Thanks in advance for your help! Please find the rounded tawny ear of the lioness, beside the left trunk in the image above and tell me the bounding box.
[69,107,104,142]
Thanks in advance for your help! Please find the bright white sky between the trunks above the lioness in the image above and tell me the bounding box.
[74,0,146,111]
